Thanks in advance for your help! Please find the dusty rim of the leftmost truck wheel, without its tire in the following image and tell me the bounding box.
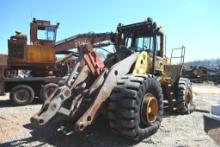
[15,88,31,102]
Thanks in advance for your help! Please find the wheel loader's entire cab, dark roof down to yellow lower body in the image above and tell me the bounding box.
[116,18,168,75]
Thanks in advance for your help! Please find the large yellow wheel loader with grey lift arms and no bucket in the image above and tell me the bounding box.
[31,18,192,141]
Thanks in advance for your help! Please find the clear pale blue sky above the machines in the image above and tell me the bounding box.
[0,0,220,61]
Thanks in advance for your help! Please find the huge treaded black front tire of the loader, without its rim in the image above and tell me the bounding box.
[108,75,163,141]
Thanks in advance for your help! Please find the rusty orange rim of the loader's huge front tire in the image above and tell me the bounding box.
[141,93,158,125]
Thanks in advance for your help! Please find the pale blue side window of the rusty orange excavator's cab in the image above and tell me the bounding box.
[37,27,56,41]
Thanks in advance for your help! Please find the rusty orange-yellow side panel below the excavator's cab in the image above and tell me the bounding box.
[26,45,56,63]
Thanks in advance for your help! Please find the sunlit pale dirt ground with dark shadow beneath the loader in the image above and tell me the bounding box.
[0,84,220,147]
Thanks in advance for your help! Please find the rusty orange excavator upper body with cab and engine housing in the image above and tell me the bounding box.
[8,18,59,76]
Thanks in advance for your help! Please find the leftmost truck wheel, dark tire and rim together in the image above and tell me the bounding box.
[10,85,34,106]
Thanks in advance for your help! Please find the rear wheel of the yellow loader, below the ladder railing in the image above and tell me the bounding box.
[176,77,194,114]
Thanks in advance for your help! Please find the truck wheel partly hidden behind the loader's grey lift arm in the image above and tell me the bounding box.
[40,83,58,102]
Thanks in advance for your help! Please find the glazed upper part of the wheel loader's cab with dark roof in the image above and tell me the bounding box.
[117,18,165,57]
